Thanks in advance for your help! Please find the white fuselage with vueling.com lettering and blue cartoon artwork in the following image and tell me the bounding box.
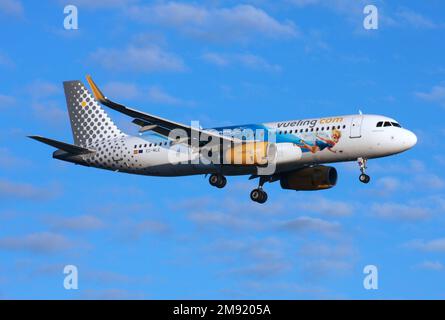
[73,115,417,176]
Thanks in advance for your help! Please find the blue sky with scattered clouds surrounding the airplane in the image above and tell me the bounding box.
[0,0,445,299]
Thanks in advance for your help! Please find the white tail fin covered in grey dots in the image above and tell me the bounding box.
[63,81,125,147]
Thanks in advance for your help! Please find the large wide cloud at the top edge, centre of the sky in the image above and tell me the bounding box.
[127,2,299,42]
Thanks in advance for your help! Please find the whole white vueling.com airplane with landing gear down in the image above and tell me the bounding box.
[29,75,417,204]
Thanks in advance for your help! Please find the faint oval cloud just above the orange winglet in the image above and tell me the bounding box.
[91,46,186,72]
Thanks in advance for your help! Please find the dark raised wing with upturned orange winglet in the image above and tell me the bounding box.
[87,75,236,144]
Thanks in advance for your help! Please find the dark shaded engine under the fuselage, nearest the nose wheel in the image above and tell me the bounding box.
[280,166,338,190]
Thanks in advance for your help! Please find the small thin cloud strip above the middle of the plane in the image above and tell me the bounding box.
[202,52,281,72]
